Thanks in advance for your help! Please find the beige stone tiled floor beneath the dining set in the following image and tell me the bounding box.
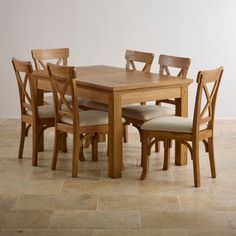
[0,119,236,236]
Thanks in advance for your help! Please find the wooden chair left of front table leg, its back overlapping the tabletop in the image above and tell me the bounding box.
[47,63,108,177]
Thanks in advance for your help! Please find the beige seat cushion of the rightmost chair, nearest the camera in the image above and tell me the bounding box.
[141,116,207,133]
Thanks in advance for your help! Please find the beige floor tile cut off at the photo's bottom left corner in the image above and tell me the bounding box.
[1,229,94,236]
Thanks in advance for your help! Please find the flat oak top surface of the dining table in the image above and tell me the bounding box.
[33,65,193,92]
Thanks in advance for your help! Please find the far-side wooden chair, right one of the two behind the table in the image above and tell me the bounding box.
[122,55,191,152]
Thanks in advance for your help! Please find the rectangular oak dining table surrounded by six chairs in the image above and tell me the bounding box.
[31,65,193,178]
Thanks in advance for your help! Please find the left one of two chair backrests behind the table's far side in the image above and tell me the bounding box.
[125,50,154,72]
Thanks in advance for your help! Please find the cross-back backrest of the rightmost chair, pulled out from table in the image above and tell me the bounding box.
[193,67,223,132]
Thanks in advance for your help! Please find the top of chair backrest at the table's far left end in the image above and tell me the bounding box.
[31,48,69,70]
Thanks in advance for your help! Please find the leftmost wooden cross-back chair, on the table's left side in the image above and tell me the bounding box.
[12,58,54,166]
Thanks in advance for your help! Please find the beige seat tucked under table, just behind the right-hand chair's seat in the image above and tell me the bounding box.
[122,105,175,121]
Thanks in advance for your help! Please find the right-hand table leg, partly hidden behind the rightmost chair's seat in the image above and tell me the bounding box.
[175,87,188,166]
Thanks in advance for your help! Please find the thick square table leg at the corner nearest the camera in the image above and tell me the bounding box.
[108,94,122,178]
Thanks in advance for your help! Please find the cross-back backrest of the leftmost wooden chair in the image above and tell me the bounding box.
[12,58,37,114]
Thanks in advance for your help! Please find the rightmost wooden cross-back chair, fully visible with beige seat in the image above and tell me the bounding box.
[141,67,223,187]
